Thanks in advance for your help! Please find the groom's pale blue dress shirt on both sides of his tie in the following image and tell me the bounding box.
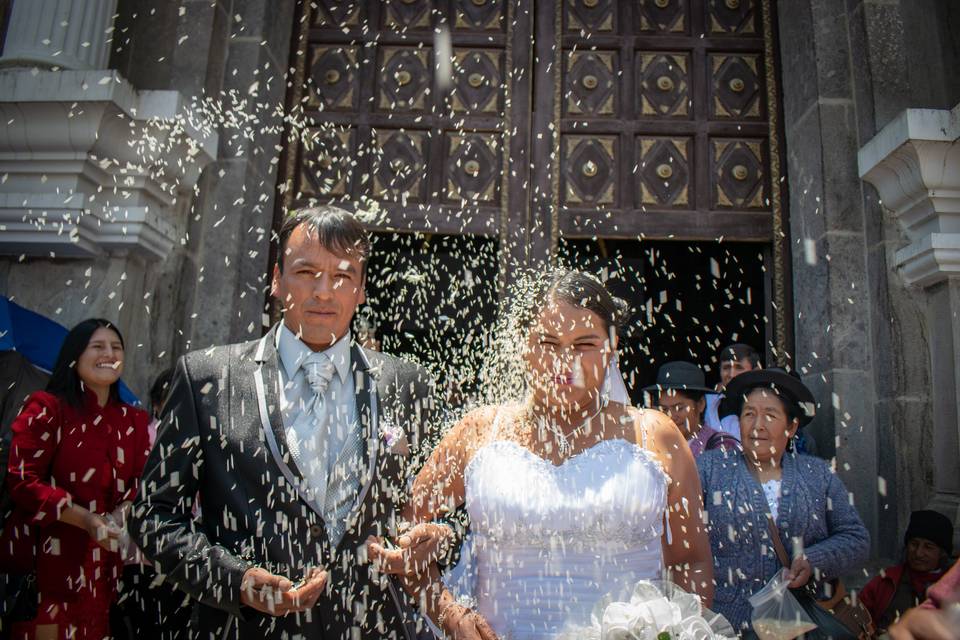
[277,322,360,488]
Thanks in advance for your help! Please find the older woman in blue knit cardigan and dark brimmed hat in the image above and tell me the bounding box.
[698,369,870,631]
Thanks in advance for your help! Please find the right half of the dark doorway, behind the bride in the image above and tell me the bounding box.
[560,239,768,403]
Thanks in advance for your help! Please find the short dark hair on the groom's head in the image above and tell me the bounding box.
[277,204,371,278]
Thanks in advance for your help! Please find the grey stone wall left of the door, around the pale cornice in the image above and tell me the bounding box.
[0,0,295,397]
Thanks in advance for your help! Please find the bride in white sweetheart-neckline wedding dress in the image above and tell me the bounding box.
[394,271,713,640]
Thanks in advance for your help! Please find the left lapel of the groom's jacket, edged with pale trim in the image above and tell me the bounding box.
[253,324,323,518]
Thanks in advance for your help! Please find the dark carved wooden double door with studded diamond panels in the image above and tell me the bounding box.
[278,0,790,360]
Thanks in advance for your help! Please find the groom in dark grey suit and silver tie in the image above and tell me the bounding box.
[130,206,447,640]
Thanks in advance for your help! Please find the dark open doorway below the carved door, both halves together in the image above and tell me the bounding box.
[360,233,768,403]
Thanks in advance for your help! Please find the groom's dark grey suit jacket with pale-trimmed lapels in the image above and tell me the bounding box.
[130,326,435,640]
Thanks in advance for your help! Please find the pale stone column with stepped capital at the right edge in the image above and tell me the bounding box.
[859,105,960,544]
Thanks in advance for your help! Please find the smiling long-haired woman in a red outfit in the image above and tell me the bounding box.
[0,319,149,640]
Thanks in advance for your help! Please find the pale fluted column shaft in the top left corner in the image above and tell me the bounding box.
[0,0,117,70]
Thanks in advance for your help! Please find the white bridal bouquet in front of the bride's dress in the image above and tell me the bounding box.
[560,580,735,640]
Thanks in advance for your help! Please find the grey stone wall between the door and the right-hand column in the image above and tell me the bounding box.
[778,0,960,558]
